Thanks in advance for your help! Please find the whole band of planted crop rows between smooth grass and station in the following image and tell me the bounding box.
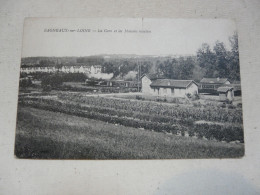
[20,94,244,143]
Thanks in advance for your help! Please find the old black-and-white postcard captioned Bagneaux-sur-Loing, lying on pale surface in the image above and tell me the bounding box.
[15,18,245,159]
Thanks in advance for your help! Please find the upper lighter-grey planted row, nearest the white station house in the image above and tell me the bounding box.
[59,94,242,123]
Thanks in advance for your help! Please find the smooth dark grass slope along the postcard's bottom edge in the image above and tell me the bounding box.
[15,106,244,159]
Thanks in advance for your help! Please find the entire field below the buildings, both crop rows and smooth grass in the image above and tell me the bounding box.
[15,92,244,159]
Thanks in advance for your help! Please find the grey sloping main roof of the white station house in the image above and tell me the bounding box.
[151,79,197,88]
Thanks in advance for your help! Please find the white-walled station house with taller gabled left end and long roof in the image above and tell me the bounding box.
[141,75,198,97]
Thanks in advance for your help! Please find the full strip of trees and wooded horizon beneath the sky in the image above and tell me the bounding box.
[19,33,240,82]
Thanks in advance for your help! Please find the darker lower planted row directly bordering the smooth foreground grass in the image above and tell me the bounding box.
[20,99,243,143]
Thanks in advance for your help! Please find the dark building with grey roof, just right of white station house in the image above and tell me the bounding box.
[199,78,231,92]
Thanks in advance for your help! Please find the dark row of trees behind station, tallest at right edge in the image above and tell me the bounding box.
[99,33,240,81]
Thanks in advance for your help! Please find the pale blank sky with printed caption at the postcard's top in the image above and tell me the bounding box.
[22,18,236,57]
